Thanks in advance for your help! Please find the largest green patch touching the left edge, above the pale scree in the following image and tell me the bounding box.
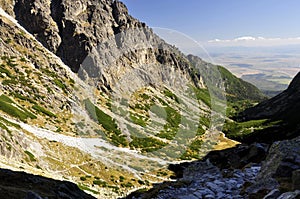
[0,95,37,122]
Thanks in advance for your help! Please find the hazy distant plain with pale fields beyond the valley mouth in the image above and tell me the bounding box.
[199,45,300,96]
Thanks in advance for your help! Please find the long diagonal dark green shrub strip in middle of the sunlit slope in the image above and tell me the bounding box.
[84,99,128,146]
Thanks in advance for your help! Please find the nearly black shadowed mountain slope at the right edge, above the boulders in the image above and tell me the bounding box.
[237,73,300,142]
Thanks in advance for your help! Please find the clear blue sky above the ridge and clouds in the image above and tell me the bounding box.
[122,0,300,43]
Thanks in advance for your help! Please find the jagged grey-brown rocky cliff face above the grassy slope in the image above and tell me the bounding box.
[7,0,263,100]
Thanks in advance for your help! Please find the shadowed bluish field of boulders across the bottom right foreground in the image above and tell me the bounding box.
[126,137,300,199]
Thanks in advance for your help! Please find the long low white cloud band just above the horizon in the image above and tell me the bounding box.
[208,36,300,46]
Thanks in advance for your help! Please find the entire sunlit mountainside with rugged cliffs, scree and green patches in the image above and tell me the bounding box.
[0,0,263,198]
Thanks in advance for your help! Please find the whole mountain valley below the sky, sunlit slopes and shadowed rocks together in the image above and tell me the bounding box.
[0,0,300,198]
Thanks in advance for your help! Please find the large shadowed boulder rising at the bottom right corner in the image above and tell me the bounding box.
[245,137,300,198]
